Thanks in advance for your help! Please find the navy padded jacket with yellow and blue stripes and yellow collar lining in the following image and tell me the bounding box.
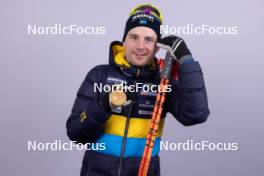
[67,41,209,175]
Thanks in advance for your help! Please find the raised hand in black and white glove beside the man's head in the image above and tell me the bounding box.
[157,35,192,61]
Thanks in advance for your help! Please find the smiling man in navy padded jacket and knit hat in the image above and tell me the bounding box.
[67,4,209,176]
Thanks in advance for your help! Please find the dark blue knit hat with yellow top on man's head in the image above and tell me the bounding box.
[123,4,163,41]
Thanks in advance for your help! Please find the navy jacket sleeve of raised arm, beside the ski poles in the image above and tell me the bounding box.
[168,61,210,126]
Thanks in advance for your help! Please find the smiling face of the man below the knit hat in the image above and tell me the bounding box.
[123,26,157,66]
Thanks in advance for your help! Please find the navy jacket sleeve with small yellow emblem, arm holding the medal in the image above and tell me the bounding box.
[66,67,110,143]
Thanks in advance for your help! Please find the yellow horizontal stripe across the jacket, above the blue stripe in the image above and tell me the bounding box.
[105,114,164,138]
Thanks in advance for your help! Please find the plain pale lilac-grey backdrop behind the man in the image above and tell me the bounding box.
[0,0,264,176]
